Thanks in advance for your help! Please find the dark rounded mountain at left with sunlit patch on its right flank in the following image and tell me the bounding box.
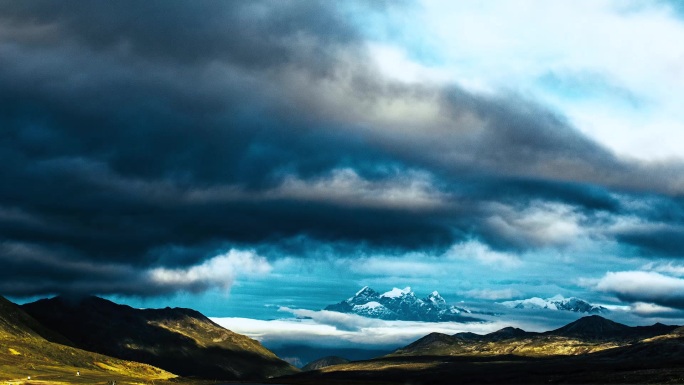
[22,297,297,380]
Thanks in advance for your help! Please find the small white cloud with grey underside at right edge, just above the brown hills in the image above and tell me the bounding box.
[594,271,684,309]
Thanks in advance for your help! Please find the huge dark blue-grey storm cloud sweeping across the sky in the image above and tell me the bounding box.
[0,1,682,295]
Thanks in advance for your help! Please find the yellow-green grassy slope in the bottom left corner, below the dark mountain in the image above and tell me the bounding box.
[0,297,175,383]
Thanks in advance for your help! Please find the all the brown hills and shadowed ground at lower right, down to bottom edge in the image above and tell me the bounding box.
[288,315,684,385]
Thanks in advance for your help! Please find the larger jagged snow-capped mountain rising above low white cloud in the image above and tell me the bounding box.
[324,286,481,322]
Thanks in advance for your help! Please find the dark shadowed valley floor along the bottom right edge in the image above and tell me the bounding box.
[279,356,684,385]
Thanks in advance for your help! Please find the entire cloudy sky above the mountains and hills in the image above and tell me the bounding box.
[0,0,684,352]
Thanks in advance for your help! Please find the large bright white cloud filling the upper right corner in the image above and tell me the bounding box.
[400,0,684,159]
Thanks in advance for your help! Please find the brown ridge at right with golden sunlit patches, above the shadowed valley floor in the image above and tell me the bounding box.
[390,315,677,357]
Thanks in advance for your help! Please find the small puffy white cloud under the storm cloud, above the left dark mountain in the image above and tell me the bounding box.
[148,250,271,291]
